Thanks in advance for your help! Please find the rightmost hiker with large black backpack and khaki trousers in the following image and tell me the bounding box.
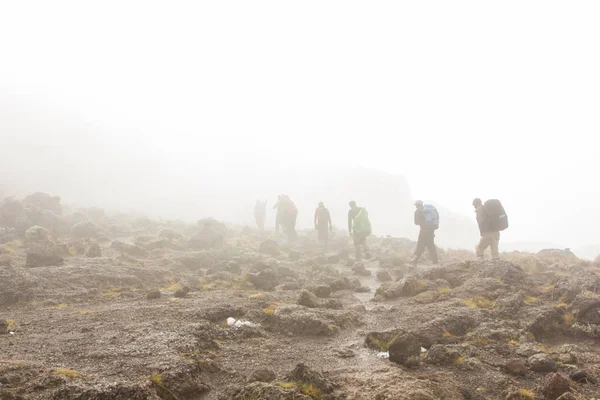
[473,198,508,260]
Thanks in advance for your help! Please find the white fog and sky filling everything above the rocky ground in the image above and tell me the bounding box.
[0,1,600,256]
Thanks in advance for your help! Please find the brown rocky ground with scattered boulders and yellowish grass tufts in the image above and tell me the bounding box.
[0,194,600,400]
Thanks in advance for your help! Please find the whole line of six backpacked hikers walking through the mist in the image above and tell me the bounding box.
[254,194,508,265]
